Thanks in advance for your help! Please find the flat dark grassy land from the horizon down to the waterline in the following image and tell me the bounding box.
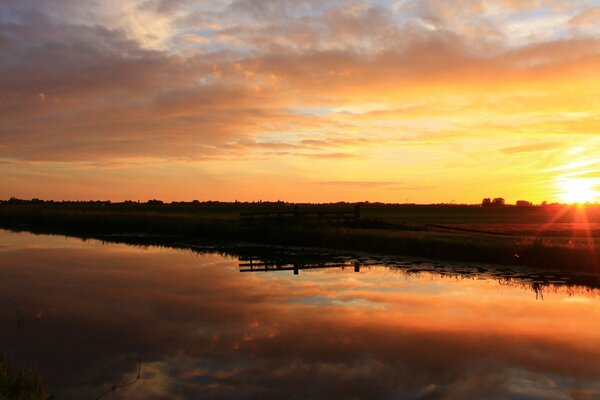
[0,203,600,272]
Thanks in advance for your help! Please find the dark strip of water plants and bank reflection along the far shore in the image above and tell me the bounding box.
[5,228,600,298]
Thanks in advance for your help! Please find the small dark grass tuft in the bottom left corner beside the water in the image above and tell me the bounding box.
[0,354,53,400]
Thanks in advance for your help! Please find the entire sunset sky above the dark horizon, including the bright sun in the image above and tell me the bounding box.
[0,0,600,203]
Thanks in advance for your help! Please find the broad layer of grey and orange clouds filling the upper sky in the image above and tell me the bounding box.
[0,0,600,200]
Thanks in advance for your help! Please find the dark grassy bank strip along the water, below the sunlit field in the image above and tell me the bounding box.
[0,205,600,273]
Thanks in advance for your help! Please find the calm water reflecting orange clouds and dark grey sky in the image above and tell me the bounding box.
[0,231,600,399]
